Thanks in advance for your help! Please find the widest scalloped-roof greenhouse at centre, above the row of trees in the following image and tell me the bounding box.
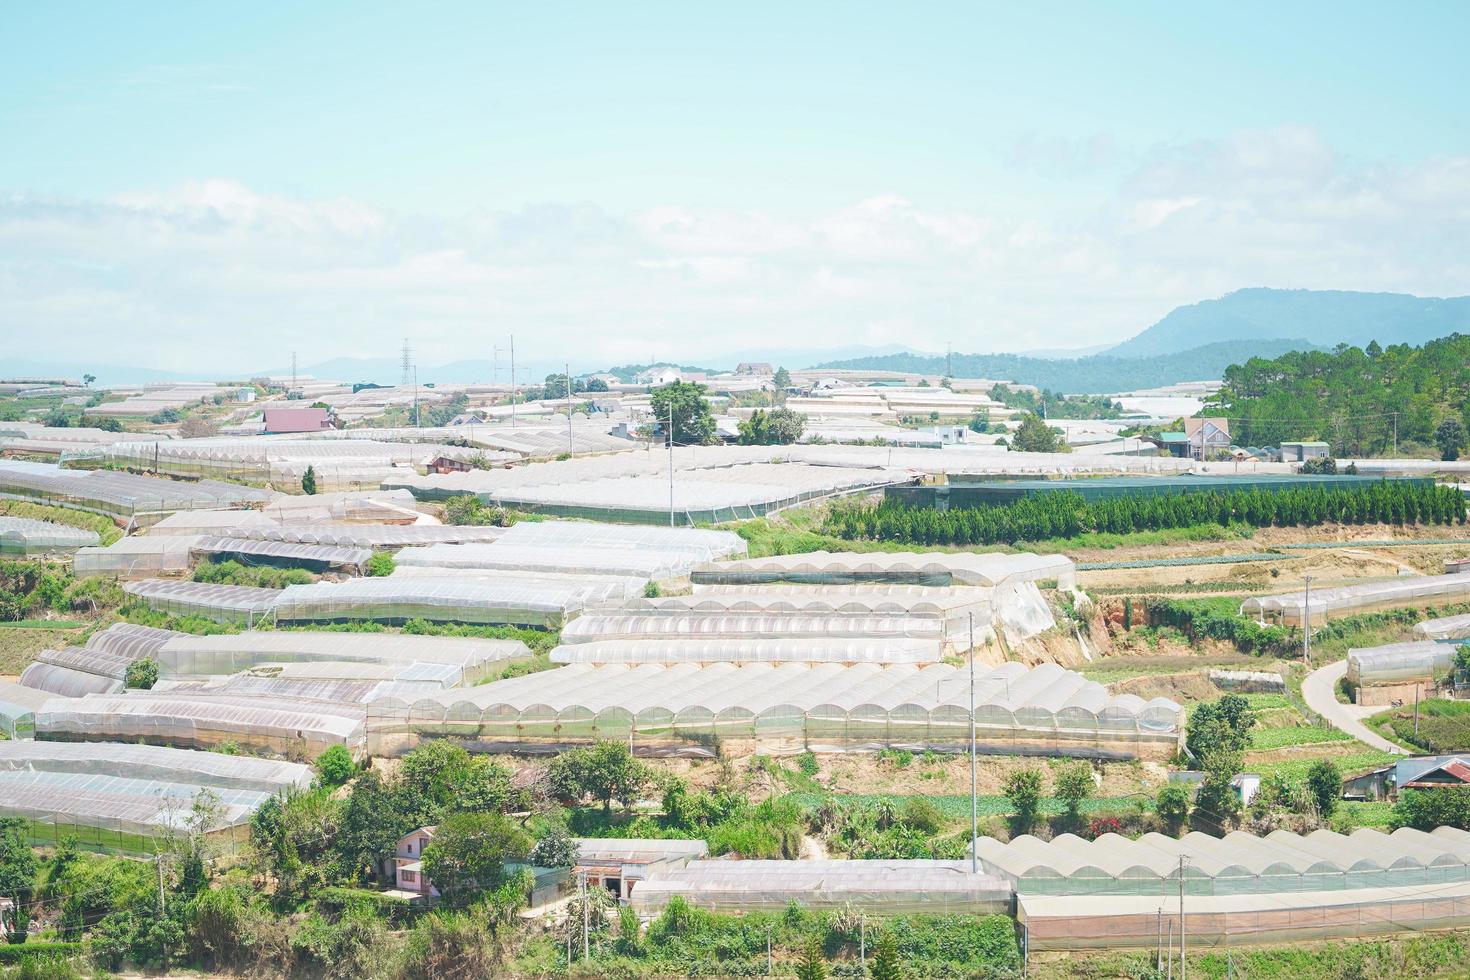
[368,658,1183,758]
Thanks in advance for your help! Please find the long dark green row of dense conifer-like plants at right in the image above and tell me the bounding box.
[825,482,1466,545]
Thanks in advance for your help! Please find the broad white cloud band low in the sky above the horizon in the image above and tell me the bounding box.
[0,128,1470,372]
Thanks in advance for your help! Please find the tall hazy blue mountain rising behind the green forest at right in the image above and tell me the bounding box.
[1108,289,1470,359]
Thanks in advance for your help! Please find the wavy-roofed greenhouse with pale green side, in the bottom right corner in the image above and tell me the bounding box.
[976,827,1470,896]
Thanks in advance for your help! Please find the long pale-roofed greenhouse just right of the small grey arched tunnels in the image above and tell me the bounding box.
[153,630,531,686]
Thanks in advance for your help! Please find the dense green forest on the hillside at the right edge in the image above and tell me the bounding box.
[1202,334,1470,455]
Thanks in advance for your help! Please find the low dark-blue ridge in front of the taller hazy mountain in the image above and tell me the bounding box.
[817,339,1313,395]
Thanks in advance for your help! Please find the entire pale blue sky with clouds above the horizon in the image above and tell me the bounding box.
[0,0,1470,375]
